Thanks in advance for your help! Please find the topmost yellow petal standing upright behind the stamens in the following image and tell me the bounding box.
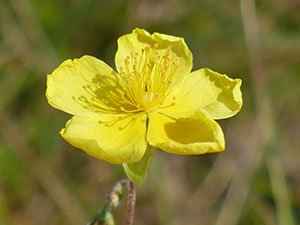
[115,28,193,89]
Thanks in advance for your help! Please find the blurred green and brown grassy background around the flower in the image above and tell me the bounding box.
[0,0,300,225]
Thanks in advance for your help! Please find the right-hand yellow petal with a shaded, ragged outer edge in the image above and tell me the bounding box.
[160,69,242,119]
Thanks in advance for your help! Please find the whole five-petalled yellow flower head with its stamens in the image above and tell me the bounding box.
[46,29,242,164]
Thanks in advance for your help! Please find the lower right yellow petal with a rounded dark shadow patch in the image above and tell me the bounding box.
[147,111,225,155]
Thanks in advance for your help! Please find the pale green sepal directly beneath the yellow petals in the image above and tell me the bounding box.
[123,145,156,186]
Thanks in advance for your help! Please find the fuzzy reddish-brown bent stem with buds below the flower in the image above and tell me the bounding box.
[86,179,136,225]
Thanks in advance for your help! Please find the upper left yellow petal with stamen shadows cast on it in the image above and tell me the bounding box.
[46,56,123,115]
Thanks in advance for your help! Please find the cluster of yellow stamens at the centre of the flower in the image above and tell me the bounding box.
[119,43,179,113]
